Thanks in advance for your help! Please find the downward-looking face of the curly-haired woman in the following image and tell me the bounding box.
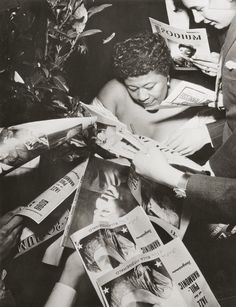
[124,71,168,112]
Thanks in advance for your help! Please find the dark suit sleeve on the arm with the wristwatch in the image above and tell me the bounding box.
[186,174,236,223]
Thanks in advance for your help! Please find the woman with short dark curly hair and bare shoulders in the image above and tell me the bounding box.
[97,32,214,146]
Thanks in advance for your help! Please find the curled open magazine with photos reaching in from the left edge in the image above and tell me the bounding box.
[0,117,96,176]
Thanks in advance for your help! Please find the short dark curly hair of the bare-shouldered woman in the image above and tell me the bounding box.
[113,32,172,80]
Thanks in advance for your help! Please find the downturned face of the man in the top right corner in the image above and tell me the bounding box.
[182,0,236,29]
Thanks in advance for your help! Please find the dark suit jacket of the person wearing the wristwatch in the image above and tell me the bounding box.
[186,130,236,223]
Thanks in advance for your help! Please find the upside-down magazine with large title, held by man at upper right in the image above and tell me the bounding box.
[149,18,211,70]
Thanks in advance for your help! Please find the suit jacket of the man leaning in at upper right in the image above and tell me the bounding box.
[208,16,236,148]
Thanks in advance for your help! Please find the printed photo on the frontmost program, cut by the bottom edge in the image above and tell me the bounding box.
[100,258,187,307]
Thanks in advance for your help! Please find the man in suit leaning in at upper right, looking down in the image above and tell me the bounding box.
[165,0,236,153]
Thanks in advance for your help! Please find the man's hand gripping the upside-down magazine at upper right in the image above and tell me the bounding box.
[190,52,220,77]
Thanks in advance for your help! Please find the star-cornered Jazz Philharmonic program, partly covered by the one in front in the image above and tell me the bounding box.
[71,207,162,306]
